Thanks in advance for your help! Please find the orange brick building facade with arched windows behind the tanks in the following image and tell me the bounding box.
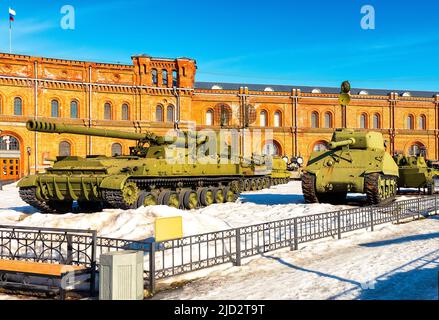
[0,54,439,180]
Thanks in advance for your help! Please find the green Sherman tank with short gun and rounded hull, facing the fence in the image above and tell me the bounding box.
[302,129,399,205]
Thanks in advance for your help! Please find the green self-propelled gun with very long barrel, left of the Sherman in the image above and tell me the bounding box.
[18,120,243,213]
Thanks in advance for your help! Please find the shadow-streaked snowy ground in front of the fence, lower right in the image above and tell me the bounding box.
[154,217,439,300]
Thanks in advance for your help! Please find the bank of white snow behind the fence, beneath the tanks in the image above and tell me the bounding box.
[0,181,358,240]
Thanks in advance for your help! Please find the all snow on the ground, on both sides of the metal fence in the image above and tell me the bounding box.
[0,181,439,300]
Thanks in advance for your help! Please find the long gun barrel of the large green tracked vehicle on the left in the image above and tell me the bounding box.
[26,120,207,145]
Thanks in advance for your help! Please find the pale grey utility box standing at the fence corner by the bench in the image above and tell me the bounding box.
[99,251,144,300]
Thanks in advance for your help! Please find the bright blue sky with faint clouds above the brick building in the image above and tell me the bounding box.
[0,0,439,91]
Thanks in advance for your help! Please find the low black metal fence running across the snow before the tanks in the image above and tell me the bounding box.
[0,196,438,292]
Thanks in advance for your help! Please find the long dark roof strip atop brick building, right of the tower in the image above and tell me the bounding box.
[195,82,438,98]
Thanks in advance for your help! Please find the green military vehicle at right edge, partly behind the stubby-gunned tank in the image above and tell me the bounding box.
[394,154,439,195]
